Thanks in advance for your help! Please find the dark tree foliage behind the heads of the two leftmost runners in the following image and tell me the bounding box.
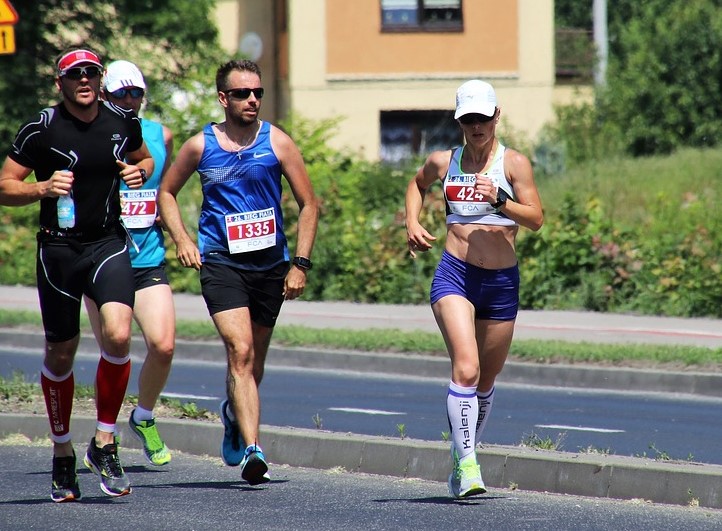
[0,0,223,157]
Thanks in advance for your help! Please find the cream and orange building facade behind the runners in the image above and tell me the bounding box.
[217,0,569,161]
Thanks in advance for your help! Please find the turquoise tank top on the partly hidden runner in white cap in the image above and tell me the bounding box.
[120,120,166,269]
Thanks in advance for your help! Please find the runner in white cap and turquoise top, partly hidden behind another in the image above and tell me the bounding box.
[85,60,175,466]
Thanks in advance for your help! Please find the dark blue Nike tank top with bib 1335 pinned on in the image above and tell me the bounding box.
[198,122,289,271]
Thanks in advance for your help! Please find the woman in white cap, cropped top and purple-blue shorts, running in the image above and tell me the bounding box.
[406,79,544,498]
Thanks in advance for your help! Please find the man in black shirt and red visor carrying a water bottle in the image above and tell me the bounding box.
[0,49,153,502]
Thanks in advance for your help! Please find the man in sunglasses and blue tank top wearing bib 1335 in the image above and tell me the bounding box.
[158,61,318,485]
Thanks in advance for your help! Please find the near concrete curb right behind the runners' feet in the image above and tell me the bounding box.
[0,413,722,509]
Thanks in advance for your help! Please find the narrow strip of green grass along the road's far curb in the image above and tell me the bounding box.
[0,310,722,371]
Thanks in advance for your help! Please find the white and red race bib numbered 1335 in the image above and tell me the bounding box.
[226,208,276,254]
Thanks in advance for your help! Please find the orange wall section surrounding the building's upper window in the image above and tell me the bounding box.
[326,0,519,75]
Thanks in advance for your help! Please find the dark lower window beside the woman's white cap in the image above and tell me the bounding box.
[380,111,463,162]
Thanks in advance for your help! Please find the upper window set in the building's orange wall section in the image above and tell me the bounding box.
[381,0,464,31]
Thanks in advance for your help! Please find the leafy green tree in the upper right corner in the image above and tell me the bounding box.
[599,0,722,155]
